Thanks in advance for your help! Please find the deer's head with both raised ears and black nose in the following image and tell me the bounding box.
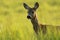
[23,2,39,19]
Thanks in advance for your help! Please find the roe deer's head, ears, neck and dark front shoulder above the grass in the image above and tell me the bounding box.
[23,2,46,34]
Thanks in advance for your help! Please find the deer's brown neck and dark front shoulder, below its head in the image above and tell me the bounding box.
[31,16,47,34]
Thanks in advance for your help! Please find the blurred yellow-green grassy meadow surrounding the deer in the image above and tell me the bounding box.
[0,0,60,40]
